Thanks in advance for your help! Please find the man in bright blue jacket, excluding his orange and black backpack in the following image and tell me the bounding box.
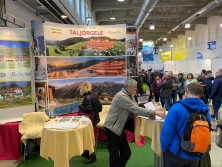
[160,83,211,167]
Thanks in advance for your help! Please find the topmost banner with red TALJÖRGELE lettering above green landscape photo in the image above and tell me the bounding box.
[44,22,126,57]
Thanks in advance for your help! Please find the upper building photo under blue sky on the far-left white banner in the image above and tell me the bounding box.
[0,40,30,69]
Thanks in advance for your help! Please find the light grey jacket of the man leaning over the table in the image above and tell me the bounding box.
[104,89,155,136]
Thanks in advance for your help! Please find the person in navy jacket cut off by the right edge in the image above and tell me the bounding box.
[209,69,222,121]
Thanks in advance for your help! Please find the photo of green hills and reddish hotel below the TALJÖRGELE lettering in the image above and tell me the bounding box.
[45,36,125,57]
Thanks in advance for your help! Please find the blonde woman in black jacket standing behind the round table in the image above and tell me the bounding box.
[79,82,102,164]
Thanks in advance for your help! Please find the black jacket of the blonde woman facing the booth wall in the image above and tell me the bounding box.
[79,92,102,126]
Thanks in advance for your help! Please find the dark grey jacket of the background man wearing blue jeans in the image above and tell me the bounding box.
[158,79,173,98]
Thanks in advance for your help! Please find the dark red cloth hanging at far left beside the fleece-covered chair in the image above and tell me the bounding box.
[0,122,22,160]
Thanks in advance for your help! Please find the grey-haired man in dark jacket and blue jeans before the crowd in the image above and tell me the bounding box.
[158,72,173,111]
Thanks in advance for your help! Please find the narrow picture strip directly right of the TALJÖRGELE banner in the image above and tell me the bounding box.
[126,26,138,55]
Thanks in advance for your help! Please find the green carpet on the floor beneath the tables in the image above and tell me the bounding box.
[17,138,154,167]
